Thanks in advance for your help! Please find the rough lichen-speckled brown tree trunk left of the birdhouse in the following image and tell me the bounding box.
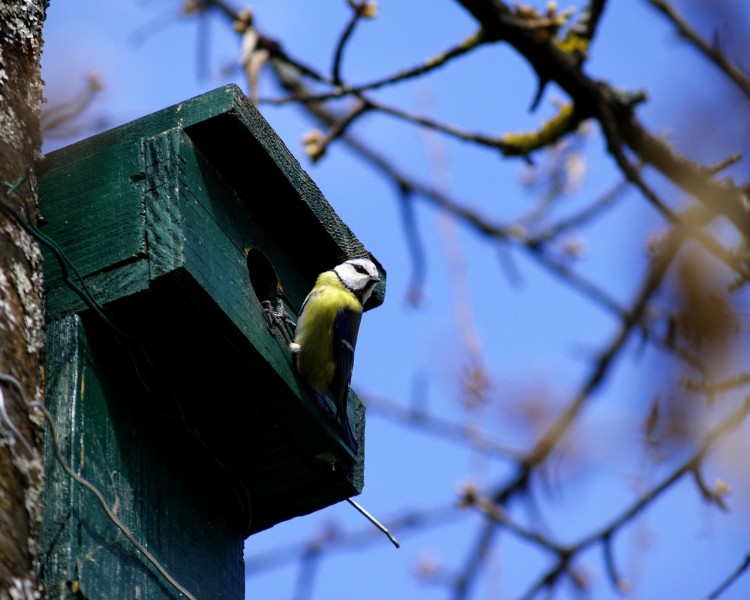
[0,0,47,600]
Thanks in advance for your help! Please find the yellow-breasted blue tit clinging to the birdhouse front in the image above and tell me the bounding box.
[289,258,380,452]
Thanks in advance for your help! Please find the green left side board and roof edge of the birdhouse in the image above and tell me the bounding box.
[39,86,241,298]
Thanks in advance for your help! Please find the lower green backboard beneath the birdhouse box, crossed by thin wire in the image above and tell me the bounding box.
[42,315,244,600]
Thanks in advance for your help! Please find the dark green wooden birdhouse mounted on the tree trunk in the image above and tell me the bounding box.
[39,85,385,600]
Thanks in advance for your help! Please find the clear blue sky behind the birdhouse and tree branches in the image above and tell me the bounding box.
[43,0,750,600]
